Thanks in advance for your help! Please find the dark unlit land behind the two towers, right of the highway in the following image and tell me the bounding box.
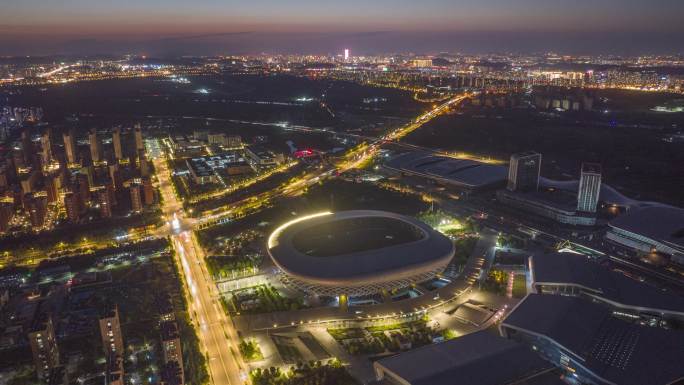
[406,106,684,206]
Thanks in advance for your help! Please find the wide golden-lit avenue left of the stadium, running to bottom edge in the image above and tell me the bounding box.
[154,157,247,385]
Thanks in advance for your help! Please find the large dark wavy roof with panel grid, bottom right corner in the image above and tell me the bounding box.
[502,294,684,385]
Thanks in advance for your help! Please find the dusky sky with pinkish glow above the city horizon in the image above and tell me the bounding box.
[0,0,684,55]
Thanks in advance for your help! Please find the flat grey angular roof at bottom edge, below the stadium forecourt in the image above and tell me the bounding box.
[375,331,561,385]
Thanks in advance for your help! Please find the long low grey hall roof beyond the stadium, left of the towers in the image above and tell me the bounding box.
[385,152,508,188]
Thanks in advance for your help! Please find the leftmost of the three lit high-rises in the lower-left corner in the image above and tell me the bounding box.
[28,315,59,379]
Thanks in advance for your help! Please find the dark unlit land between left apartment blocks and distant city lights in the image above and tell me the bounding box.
[5,75,426,134]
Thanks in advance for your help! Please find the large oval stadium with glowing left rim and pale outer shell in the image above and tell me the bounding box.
[268,210,454,296]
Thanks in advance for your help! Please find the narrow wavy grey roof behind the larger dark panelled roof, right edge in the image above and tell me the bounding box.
[532,253,684,315]
